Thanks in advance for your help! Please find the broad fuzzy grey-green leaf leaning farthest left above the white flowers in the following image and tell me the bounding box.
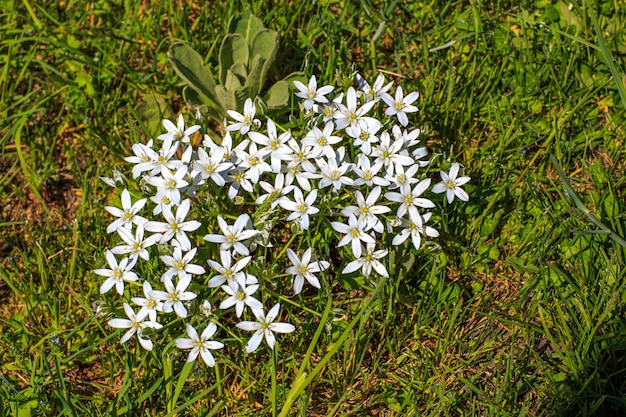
[167,42,225,113]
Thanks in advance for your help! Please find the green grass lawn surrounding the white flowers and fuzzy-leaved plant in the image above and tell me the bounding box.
[0,0,626,416]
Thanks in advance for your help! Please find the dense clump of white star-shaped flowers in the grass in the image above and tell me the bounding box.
[94,75,470,366]
